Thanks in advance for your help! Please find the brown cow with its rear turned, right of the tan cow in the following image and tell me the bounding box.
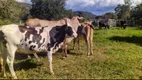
[73,21,94,56]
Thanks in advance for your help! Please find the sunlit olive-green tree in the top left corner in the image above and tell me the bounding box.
[0,0,23,21]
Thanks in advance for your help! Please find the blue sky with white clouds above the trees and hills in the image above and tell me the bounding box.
[17,0,142,15]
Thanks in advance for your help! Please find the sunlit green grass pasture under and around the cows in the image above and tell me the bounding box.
[1,28,142,79]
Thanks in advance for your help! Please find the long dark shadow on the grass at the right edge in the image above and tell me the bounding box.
[109,36,142,46]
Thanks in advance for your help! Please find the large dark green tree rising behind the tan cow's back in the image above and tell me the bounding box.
[30,0,66,20]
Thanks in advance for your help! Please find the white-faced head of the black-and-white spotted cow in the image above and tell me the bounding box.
[65,23,77,37]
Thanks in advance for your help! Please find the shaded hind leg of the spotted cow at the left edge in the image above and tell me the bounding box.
[1,48,7,77]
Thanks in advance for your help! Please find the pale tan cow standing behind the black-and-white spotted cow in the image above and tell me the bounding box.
[25,16,83,59]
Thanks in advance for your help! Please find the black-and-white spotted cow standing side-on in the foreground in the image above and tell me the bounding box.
[0,22,77,79]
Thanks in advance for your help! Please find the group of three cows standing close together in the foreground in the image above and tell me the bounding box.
[0,16,94,79]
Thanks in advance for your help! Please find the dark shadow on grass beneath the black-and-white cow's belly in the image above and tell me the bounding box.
[14,59,42,70]
